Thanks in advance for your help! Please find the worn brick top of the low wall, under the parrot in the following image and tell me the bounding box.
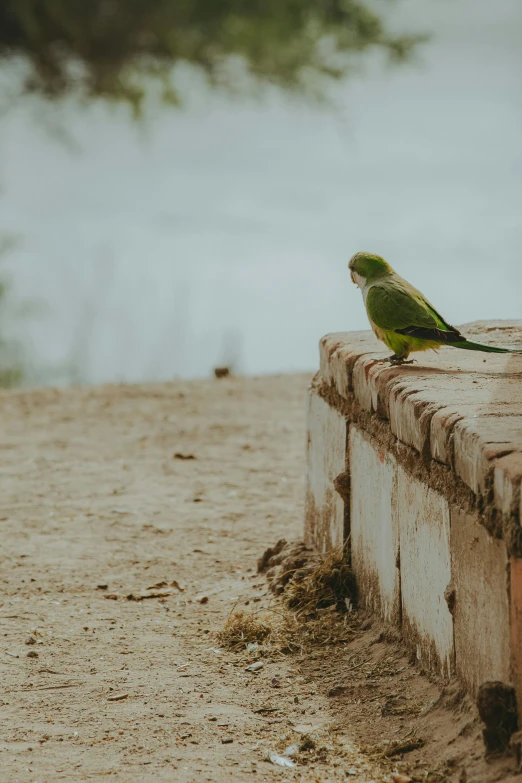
[321,321,522,519]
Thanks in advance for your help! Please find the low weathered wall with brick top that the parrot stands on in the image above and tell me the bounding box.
[306,322,522,718]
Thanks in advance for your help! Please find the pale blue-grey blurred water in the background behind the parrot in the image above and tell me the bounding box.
[0,0,522,383]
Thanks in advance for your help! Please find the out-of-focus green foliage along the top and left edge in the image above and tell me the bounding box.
[0,0,420,387]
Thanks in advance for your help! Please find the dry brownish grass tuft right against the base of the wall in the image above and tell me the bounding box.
[284,547,356,614]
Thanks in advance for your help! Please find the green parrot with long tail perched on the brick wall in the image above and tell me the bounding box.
[348,253,522,364]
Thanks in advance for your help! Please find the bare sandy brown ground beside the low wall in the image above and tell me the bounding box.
[0,376,515,783]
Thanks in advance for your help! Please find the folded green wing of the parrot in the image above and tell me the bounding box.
[366,281,462,343]
